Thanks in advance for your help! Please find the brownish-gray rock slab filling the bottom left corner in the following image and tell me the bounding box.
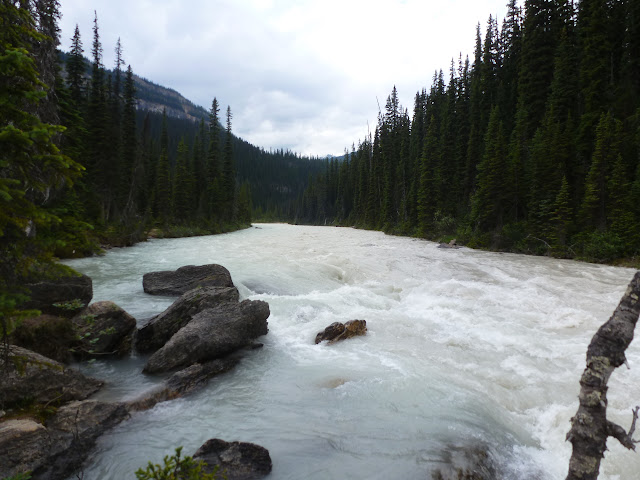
[0,400,128,480]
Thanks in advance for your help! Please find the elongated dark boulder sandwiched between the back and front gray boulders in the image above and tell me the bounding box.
[136,287,239,353]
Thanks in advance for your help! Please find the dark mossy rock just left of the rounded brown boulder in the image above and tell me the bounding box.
[11,315,77,363]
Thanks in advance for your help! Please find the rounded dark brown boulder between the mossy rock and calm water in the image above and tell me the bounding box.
[72,301,136,357]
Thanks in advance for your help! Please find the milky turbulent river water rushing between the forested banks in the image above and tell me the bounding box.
[61,224,640,480]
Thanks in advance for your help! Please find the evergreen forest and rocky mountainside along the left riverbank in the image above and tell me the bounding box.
[0,0,324,330]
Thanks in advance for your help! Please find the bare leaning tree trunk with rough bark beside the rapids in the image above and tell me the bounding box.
[566,272,640,480]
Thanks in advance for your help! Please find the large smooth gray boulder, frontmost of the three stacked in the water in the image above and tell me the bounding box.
[144,300,269,373]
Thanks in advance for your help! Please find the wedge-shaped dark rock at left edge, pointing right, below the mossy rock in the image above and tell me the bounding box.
[0,345,103,408]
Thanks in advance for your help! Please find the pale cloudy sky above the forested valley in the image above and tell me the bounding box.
[60,0,510,156]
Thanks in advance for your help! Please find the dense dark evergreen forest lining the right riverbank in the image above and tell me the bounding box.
[298,0,640,261]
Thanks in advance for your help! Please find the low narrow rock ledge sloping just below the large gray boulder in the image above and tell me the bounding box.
[128,358,239,411]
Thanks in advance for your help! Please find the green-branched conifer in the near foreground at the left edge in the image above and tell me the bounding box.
[0,2,82,328]
